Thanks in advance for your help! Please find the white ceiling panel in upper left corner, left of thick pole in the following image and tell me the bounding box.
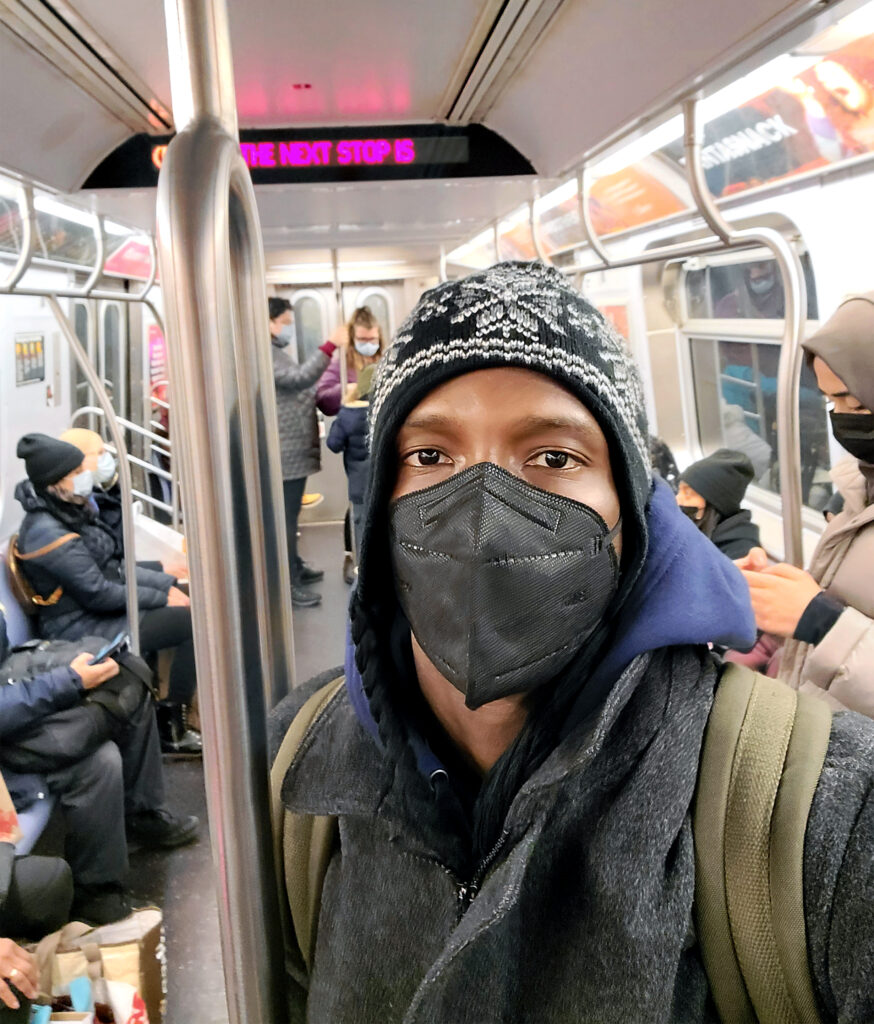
[0,25,130,190]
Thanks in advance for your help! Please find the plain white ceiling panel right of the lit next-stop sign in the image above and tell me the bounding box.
[482,0,815,174]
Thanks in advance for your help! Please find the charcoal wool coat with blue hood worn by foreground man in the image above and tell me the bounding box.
[272,485,874,1024]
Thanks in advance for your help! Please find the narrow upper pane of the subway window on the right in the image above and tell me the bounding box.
[685,253,819,319]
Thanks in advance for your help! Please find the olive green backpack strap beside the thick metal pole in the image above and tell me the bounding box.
[270,676,345,972]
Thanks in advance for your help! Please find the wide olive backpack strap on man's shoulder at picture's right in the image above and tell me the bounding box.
[694,665,831,1024]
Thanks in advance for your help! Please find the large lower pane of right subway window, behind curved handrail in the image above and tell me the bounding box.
[689,337,832,510]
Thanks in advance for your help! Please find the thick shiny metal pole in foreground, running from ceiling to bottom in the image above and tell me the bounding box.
[158,0,294,1024]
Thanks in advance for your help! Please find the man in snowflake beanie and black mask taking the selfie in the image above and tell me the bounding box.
[274,263,874,1024]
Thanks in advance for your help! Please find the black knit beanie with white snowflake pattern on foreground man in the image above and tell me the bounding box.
[369,262,652,525]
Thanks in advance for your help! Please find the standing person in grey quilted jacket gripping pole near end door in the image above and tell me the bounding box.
[267,297,346,608]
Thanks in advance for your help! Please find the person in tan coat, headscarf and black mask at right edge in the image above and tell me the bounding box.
[736,292,874,718]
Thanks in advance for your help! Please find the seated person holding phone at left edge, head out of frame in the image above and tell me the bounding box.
[0,611,199,930]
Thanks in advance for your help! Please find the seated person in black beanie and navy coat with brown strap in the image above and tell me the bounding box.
[15,434,201,755]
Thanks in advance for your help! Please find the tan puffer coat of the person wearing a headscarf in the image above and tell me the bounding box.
[780,458,874,718]
